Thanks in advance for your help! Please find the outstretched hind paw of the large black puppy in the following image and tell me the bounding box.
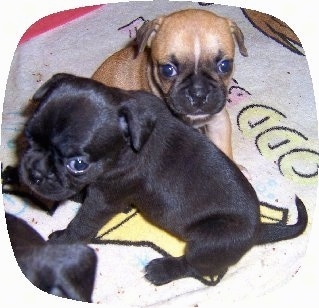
[145,257,191,286]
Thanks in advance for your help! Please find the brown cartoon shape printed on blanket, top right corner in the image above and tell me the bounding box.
[242,9,304,56]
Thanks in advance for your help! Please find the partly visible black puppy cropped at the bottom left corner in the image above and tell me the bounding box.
[6,213,97,302]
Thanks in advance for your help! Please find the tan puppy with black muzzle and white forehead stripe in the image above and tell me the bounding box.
[93,9,247,164]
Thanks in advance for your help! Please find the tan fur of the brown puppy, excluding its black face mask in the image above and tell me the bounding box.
[92,9,247,164]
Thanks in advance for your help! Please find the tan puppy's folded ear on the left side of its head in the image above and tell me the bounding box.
[136,18,162,53]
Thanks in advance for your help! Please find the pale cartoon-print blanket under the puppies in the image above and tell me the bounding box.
[1,0,319,306]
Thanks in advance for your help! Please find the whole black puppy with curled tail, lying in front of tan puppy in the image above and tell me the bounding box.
[20,74,307,285]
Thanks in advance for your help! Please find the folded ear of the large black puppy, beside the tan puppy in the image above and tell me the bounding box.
[118,99,156,152]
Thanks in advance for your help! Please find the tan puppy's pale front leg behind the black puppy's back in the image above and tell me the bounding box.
[205,107,251,180]
